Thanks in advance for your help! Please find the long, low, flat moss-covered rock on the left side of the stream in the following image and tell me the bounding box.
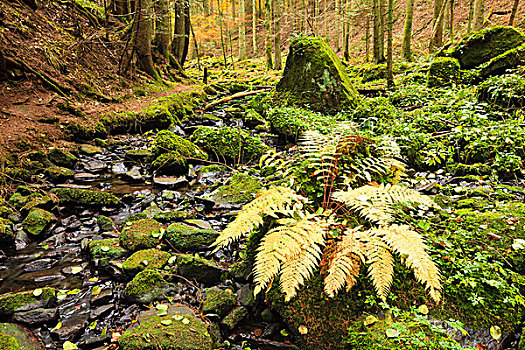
[51,188,119,206]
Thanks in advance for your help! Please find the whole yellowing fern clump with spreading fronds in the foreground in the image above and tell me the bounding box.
[211,127,441,302]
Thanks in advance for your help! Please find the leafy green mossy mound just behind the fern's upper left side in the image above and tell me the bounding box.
[191,126,268,163]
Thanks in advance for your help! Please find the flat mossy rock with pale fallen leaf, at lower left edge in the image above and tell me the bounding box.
[0,287,56,315]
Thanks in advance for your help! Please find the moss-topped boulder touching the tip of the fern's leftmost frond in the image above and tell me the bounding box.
[164,223,219,251]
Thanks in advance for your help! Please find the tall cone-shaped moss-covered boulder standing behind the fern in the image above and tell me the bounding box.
[265,37,359,114]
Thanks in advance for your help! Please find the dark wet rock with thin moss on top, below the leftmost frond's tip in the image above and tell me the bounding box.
[172,254,226,286]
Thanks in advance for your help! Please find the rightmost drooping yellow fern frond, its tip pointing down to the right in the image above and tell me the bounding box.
[382,225,441,302]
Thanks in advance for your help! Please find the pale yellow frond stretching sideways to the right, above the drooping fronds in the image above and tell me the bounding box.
[332,184,437,224]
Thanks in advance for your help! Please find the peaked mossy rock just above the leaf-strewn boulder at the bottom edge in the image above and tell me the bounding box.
[123,269,180,304]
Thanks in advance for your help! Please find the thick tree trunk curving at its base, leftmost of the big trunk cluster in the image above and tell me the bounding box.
[133,0,160,80]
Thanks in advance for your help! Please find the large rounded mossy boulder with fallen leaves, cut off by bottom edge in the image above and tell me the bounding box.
[118,305,213,350]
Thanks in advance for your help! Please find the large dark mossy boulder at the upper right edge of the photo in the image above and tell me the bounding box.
[440,26,525,69]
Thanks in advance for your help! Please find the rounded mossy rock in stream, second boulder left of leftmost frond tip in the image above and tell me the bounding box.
[119,219,162,251]
